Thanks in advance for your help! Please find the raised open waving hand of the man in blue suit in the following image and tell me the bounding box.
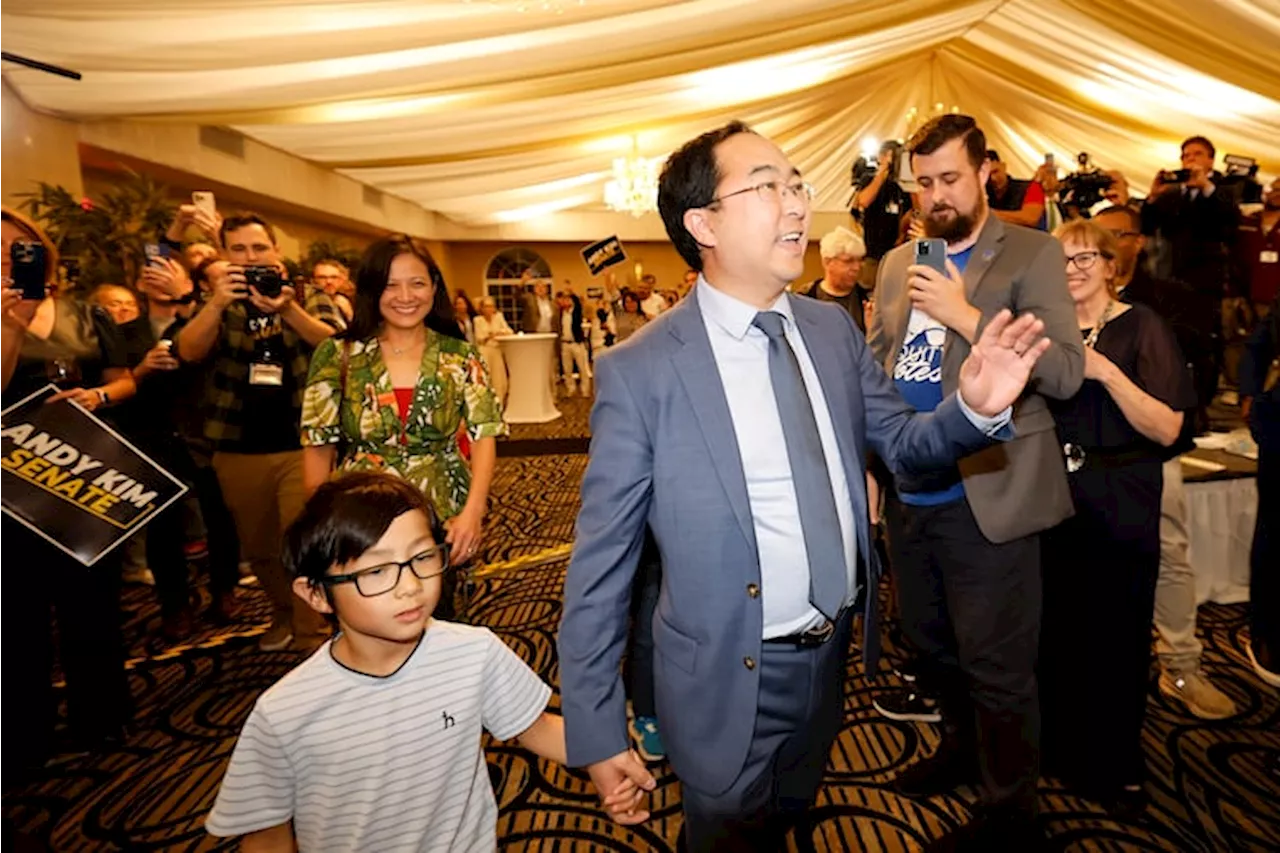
[960,309,1050,418]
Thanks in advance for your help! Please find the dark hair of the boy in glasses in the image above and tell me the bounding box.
[280,473,444,585]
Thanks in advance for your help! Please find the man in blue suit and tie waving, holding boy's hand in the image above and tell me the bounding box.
[559,123,1048,850]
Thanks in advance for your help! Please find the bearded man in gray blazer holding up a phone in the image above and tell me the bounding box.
[867,115,1087,850]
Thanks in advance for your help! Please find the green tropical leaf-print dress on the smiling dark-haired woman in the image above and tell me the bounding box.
[302,332,507,519]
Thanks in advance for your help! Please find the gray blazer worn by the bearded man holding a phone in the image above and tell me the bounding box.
[867,216,1084,542]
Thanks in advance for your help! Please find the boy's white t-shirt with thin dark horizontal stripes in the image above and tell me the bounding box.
[205,620,550,853]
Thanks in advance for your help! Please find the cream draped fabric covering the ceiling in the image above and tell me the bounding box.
[0,0,1280,224]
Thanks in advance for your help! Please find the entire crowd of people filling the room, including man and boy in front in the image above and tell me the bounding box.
[0,108,1280,853]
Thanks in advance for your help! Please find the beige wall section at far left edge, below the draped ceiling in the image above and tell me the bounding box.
[0,78,83,205]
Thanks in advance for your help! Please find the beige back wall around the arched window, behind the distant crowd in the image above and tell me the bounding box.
[445,241,822,298]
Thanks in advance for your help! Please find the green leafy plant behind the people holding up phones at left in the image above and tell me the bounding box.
[19,172,177,291]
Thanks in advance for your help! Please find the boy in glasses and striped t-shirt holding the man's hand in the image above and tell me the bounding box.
[205,474,653,853]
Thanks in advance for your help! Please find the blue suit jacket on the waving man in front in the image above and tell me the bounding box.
[559,285,989,794]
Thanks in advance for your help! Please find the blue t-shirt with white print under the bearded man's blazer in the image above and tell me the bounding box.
[893,246,973,506]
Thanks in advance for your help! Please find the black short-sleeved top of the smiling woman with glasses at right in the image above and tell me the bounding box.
[1050,305,1196,461]
